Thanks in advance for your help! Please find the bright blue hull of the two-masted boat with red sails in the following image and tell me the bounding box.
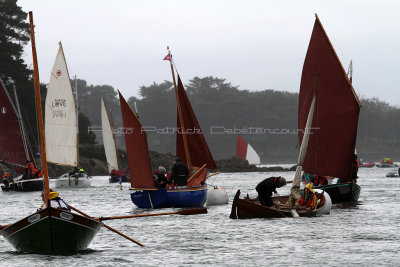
[131,185,207,209]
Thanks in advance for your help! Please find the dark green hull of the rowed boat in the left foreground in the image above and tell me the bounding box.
[1,208,101,255]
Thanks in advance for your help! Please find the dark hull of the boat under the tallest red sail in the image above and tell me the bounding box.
[315,183,361,204]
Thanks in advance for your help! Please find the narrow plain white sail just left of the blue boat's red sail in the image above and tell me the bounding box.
[101,97,118,172]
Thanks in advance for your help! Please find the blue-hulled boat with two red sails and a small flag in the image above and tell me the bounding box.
[126,50,220,208]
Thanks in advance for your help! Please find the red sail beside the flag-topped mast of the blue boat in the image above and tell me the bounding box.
[176,75,217,169]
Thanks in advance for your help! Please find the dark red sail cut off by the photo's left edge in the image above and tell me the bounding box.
[0,80,27,173]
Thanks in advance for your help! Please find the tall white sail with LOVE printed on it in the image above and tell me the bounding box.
[45,43,78,166]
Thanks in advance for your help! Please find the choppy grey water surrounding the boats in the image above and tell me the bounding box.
[0,167,400,266]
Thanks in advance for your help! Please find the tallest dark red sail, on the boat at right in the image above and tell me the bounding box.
[298,17,360,182]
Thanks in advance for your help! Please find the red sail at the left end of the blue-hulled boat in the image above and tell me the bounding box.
[119,93,154,188]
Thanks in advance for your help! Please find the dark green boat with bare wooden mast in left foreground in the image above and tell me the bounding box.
[1,12,102,255]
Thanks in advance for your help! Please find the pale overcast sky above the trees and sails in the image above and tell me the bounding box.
[18,0,400,106]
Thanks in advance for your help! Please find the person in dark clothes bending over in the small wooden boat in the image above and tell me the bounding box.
[256,176,286,207]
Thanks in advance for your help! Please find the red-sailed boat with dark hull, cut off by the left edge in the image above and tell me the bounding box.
[0,78,43,191]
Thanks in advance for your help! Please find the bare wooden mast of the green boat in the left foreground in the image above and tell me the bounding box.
[29,11,50,203]
